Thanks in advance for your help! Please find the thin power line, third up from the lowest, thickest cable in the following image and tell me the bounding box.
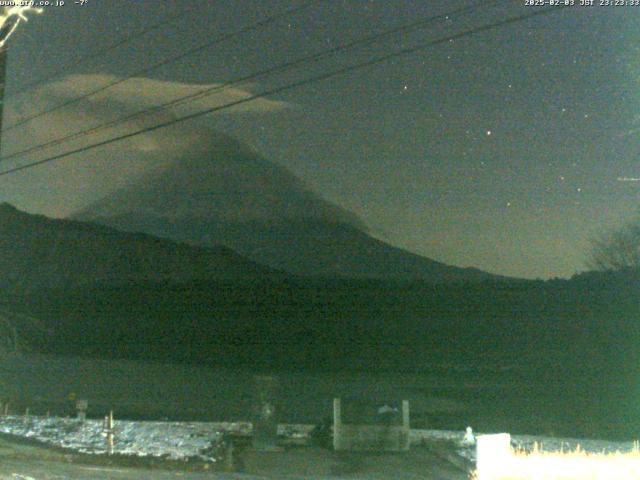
[3,0,326,132]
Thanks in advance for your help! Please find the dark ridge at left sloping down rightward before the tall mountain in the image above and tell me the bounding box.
[0,203,275,290]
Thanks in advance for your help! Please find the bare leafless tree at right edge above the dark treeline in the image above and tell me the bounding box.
[587,216,640,271]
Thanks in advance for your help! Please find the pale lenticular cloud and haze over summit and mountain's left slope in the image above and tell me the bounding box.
[1,74,289,217]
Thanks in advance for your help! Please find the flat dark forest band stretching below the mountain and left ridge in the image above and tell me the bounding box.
[21,274,640,370]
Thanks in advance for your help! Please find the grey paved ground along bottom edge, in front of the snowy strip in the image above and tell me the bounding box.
[0,436,469,480]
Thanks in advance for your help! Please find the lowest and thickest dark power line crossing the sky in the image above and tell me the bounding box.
[0,5,567,176]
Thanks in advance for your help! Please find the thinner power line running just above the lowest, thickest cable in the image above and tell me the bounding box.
[0,0,511,161]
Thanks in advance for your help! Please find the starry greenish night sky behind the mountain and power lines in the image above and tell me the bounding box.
[0,0,640,278]
